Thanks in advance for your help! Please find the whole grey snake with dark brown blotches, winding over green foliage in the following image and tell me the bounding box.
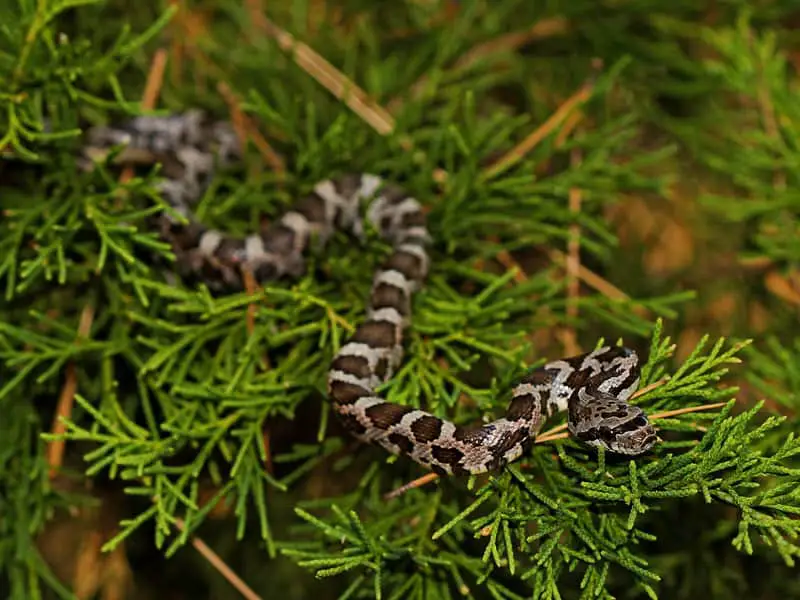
[84,111,657,475]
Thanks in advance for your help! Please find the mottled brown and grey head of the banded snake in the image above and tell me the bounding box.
[568,392,658,456]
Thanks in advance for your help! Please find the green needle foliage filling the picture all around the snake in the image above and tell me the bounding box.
[0,0,800,599]
